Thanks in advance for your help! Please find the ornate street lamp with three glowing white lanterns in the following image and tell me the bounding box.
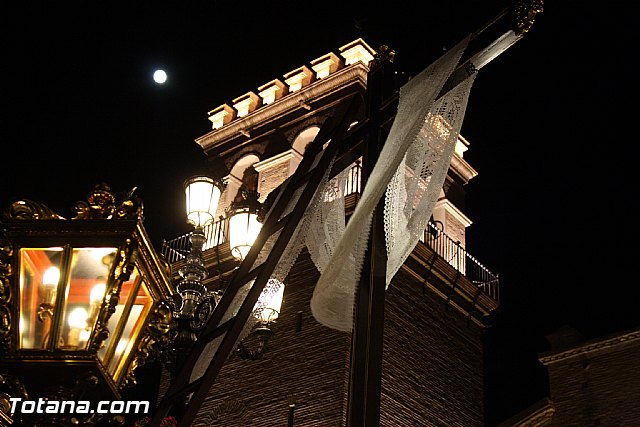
[165,171,284,364]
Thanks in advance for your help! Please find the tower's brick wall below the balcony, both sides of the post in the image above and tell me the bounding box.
[185,253,483,427]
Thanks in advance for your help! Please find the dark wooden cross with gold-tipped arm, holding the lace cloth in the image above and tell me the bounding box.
[347,0,543,427]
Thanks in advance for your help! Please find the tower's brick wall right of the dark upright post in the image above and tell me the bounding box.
[381,270,483,427]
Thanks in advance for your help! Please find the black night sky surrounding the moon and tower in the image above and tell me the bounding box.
[0,0,640,425]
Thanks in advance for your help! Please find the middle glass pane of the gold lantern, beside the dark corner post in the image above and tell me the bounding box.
[57,248,116,350]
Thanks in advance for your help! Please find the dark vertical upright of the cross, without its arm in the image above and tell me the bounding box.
[347,46,398,427]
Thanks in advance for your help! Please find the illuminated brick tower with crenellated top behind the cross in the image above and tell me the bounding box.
[162,39,498,427]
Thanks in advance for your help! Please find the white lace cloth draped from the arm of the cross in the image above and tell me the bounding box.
[307,37,472,331]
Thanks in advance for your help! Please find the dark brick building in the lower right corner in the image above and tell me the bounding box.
[500,326,640,427]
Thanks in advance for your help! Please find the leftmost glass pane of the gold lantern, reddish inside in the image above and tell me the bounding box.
[18,247,62,349]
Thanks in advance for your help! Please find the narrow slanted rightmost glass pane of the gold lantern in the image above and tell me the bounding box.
[109,280,153,382]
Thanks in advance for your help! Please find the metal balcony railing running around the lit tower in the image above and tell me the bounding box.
[161,162,500,301]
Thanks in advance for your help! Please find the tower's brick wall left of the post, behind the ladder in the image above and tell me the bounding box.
[194,255,350,427]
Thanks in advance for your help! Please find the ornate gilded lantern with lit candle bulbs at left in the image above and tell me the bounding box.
[0,184,172,425]
